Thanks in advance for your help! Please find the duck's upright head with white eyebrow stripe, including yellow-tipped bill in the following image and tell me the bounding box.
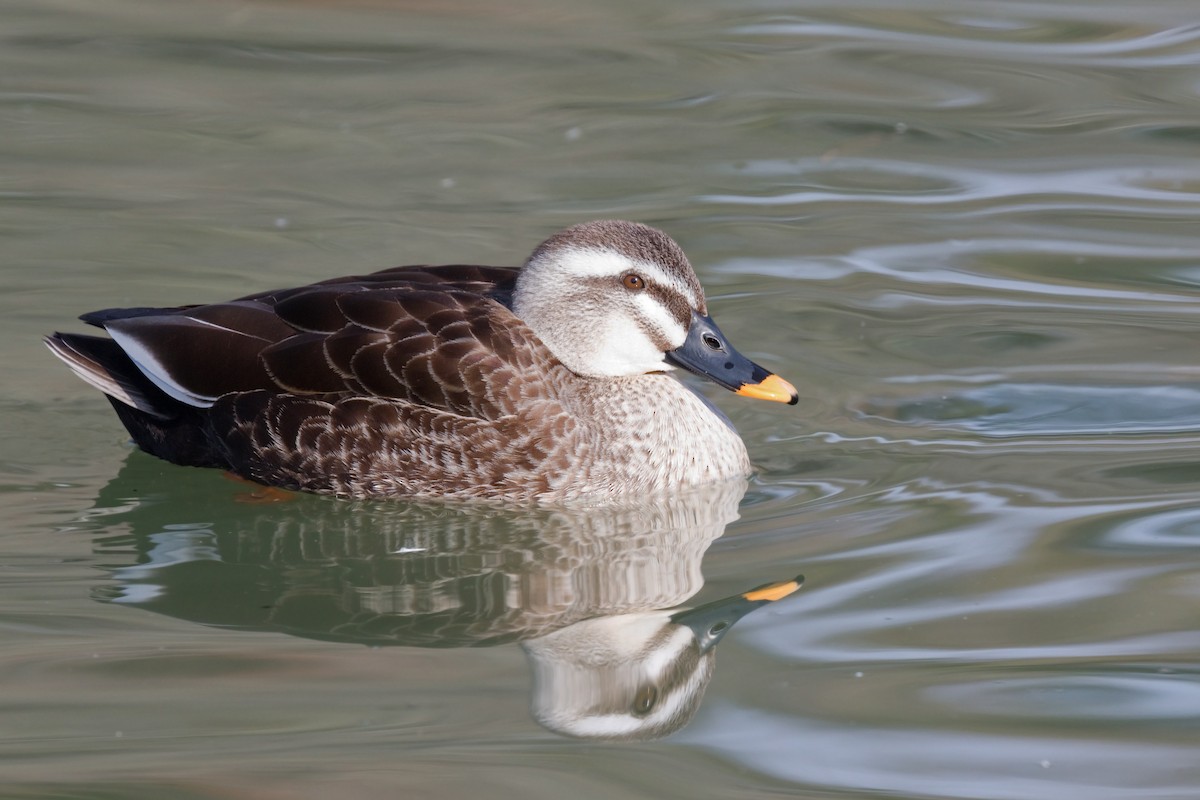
[512,221,797,404]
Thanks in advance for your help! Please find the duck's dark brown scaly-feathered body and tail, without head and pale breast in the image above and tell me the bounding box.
[48,265,585,495]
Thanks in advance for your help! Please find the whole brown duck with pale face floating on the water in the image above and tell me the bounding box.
[44,221,798,504]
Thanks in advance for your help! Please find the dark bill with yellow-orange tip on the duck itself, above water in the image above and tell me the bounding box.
[667,312,799,405]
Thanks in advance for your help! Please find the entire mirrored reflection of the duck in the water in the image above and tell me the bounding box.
[82,453,798,739]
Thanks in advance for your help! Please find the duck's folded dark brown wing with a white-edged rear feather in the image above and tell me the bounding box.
[71,266,562,419]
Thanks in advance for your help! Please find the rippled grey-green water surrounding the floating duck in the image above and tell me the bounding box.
[0,0,1200,800]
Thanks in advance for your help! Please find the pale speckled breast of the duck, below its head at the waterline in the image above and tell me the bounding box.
[559,374,750,494]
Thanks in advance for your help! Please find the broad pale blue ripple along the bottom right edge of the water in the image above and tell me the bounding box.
[686,704,1200,800]
